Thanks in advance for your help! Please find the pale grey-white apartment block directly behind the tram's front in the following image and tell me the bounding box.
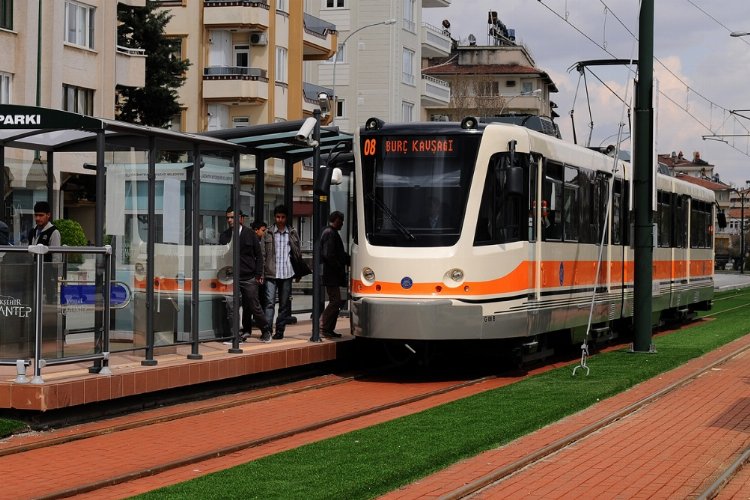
[311,0,451,132]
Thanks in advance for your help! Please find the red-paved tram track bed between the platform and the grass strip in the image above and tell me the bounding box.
[0,364,508,499]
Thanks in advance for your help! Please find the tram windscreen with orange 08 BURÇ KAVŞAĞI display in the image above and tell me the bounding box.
[362,136,479,247]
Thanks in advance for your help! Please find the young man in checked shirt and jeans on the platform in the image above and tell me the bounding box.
[263,205,302,340]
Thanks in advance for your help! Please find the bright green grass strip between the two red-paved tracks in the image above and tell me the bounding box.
[142,291,750,500]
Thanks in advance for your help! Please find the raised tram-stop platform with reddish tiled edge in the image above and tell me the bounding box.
[0,318,354,411]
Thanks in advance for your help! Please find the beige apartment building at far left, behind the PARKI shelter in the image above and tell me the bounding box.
[0,0,146,238]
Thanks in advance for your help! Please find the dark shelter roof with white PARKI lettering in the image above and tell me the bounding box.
[0,104,239,152]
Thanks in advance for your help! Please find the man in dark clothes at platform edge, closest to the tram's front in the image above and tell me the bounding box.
[320,210,349,337]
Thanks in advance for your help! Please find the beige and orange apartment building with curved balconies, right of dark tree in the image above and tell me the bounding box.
[161,0,337,132]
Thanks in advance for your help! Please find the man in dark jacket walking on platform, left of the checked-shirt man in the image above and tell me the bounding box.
[219,207,271,342]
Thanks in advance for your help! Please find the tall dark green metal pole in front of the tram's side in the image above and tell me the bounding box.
[633,0,654,352]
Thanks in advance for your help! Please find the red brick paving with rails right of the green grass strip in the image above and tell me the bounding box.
[385,335,750,499]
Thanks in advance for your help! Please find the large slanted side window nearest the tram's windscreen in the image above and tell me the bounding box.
[474,153,528,245]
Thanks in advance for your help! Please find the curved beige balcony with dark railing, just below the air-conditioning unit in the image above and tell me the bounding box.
[203,66,268,104]
